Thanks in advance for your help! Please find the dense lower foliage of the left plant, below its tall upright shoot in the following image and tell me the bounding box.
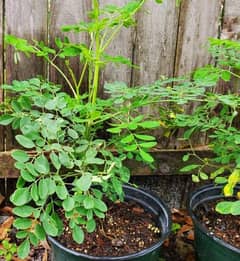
[0,70,212,258]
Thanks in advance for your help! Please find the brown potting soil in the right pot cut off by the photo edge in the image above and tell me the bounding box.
[195,200,240,248]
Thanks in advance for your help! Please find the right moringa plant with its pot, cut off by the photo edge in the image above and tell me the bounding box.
[176,39,240,261]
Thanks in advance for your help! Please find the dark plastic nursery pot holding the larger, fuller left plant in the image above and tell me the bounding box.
[48,186,171,261]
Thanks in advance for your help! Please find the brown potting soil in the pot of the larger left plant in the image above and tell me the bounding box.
[58,202,161,256]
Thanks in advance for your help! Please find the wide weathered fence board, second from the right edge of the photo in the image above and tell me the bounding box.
[175,0,222,75]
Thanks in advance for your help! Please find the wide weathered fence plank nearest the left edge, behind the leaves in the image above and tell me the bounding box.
[5,0,48,150]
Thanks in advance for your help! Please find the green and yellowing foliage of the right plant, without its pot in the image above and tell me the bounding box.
[175,39,240,215]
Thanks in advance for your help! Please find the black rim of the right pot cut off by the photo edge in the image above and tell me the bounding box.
[187,184,240,254]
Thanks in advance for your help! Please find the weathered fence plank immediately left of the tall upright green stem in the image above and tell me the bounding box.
[49,0,91,91]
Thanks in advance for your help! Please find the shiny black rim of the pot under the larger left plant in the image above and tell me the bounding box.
[47,185,172,261]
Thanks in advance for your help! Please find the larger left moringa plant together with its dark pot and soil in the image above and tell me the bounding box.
[0,0,204,261]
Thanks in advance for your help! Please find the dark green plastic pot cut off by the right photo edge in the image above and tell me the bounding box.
[188,185,240,261]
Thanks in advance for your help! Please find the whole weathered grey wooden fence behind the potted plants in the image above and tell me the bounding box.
[0,0,240,177]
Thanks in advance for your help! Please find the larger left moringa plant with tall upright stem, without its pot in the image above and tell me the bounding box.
[0,0,205,259]
